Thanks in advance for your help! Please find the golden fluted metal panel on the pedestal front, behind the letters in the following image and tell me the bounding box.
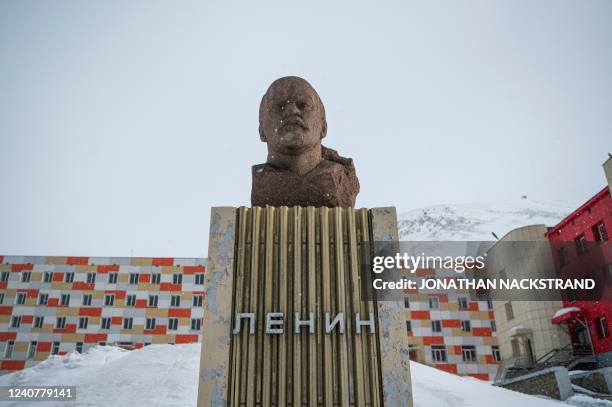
[228,207,382,407]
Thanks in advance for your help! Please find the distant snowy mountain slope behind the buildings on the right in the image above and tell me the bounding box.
[398,199,578,241]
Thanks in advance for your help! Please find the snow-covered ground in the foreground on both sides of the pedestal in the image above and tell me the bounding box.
[0,344,612,407]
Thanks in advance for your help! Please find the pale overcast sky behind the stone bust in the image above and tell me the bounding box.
[0,0,612,257]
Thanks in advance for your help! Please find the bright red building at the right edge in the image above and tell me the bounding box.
[546,187,612,367]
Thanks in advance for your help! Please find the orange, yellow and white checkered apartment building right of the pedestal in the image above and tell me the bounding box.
[404,269,501,380]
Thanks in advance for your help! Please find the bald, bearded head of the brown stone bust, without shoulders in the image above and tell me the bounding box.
[259,77,327,155]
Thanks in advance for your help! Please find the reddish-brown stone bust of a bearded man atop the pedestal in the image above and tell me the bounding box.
[251,76,359,207]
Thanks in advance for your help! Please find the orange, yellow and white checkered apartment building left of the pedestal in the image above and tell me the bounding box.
[0,256,205,374]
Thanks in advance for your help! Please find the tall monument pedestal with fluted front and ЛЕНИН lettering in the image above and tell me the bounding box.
[198,207,412,406]
